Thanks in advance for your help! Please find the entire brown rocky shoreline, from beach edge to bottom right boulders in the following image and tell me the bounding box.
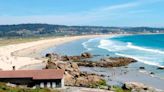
[41,53,162,92]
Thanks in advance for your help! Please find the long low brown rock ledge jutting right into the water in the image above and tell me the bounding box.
[77,57,137,67]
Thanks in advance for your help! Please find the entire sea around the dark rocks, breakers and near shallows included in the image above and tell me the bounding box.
[41,34,164,88]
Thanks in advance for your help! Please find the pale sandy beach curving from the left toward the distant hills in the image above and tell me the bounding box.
[0,34,119,70]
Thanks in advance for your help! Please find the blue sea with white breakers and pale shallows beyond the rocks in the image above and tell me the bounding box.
[41,34,164,66]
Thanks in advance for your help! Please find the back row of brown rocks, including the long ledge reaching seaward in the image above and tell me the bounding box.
[46,52,137,67]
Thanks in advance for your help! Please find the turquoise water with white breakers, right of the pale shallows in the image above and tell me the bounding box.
[98,34,164,66]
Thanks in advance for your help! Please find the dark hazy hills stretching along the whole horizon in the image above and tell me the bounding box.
[0,24,164,38]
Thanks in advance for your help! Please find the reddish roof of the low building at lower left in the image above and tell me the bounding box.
[0,69,64,80]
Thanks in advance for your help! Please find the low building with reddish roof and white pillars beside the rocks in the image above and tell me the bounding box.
[0,69,64,88]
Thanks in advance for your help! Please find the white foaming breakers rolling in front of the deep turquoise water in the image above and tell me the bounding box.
[98,39,164,66]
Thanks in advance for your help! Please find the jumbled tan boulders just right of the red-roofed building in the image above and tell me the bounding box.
[46,61,106,87]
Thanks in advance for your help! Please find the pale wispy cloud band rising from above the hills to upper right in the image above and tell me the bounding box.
[0,0,161,25]
